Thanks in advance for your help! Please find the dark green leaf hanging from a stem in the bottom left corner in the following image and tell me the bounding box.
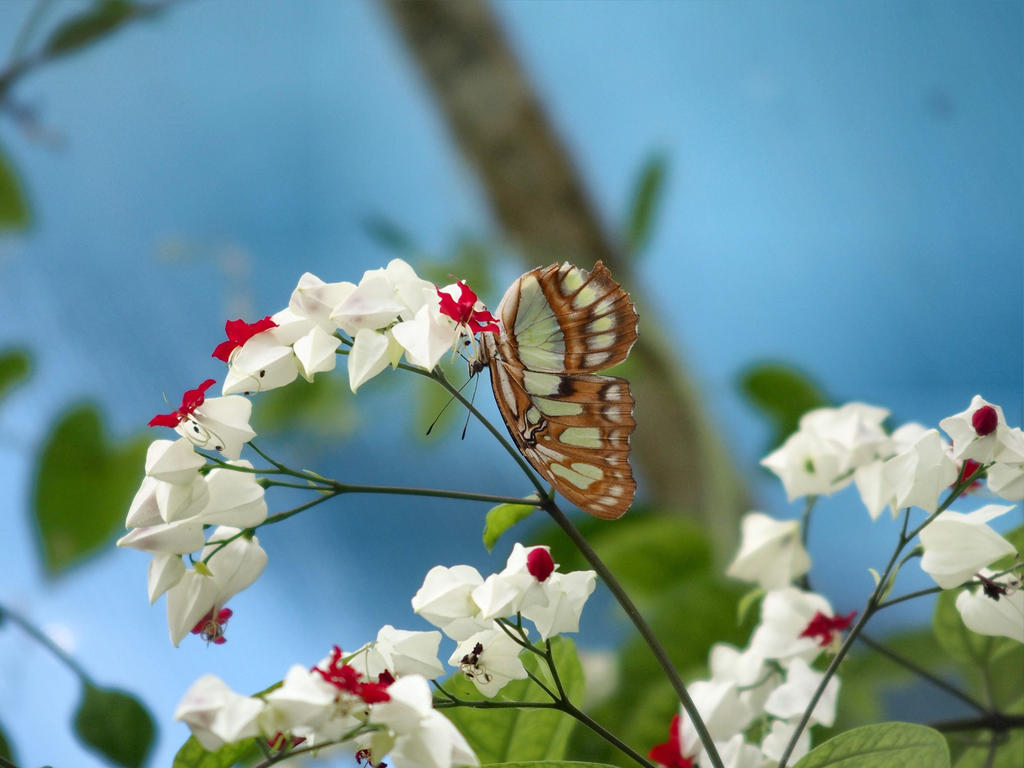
[75,683,155,768]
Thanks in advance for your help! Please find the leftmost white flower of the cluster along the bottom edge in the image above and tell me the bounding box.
[174,675,264,752]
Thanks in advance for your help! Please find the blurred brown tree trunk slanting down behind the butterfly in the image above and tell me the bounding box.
[381,0,749,547]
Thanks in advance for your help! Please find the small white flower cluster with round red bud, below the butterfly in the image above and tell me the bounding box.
[413,543,597,697]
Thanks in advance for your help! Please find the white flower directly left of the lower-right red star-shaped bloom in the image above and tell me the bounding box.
[750,587,833,662]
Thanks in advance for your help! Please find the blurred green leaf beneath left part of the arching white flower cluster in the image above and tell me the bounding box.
[253,372,359,437]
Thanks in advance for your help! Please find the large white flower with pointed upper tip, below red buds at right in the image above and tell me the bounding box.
[921,504,1014,589]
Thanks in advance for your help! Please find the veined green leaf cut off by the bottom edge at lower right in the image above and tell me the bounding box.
[795,723,949,768]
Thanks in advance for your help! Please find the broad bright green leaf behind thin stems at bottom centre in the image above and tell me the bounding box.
[442,637,584,763]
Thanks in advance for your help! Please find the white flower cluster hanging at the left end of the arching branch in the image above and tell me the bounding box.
[118,434,267,645]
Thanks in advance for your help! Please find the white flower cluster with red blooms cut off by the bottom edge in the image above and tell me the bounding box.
[174,627,478,768]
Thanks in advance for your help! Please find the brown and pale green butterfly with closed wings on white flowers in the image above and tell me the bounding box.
[476,261,637,519]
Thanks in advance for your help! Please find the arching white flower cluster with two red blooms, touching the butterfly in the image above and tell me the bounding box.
[214,259,498,394]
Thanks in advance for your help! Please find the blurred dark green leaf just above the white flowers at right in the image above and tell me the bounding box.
[739,362,828,447]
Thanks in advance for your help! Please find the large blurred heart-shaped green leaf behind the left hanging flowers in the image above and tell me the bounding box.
[33,403,148,575]
